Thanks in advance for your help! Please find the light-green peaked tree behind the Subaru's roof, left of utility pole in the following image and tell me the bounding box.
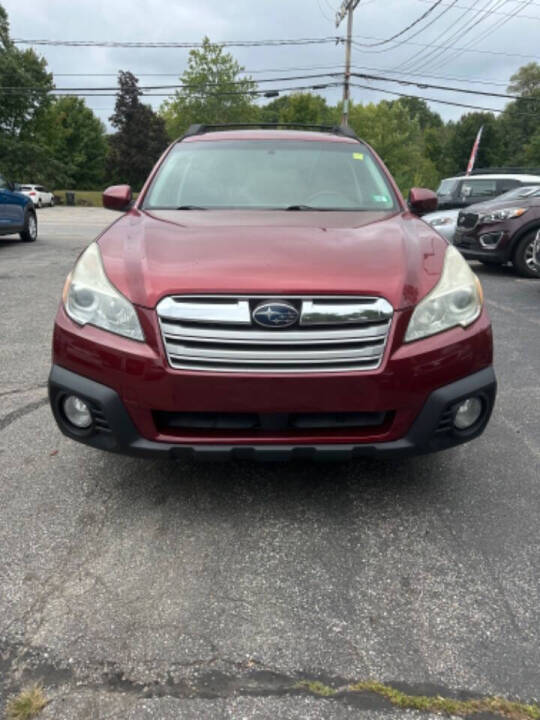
[160,37,258,139]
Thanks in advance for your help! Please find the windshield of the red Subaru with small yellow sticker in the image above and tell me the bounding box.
[143,140,397,211]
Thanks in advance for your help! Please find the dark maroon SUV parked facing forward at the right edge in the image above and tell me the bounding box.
[454,188,540,278]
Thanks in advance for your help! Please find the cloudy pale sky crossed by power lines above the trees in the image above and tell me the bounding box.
[4,0,540,129]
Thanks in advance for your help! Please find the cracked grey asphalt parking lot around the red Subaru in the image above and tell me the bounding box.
[0,208,540,720]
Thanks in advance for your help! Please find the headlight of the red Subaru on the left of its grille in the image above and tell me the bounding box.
[62,242,144,340]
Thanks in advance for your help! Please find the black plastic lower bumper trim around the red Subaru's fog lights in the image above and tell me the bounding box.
[49,365,497,460]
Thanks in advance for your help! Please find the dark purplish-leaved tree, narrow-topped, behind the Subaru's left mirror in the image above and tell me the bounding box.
[107,71,168,190]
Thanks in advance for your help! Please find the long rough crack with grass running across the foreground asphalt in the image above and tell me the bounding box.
[0,640,540,720]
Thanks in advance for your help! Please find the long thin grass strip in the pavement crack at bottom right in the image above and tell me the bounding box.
[295,680,540,720]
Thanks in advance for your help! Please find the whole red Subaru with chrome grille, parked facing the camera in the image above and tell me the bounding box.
[49,126,496,458]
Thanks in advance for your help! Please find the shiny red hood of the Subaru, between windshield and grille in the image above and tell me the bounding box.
[99,209,447,308]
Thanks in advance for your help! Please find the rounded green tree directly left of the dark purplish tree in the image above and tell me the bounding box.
[37,97,107,189]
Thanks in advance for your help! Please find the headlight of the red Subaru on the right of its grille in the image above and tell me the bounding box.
[405,246,483,342]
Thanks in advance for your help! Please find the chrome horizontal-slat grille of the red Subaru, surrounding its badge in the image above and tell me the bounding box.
[157,296,393,373]
